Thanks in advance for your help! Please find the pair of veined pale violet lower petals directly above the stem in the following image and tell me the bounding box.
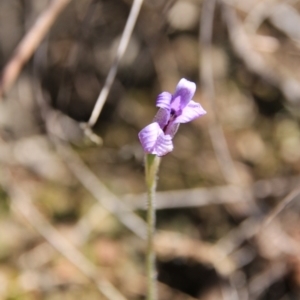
[139,122,173,156]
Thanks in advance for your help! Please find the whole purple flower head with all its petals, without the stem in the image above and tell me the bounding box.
[139,78,206,156]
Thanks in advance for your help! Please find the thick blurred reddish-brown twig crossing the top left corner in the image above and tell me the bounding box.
[0,0,71,98]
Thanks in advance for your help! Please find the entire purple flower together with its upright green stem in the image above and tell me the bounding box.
[138,78,206,300]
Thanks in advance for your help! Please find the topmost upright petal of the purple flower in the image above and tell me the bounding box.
[171,78,196,112]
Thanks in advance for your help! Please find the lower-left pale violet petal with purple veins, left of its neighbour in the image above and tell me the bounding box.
[138,122,164,154]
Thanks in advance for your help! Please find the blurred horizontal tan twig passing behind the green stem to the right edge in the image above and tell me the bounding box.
[122,176,300,210]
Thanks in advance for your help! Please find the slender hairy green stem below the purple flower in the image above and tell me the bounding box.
[145,154,160,300]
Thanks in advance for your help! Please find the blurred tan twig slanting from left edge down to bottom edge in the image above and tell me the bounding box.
[2,173,126,300]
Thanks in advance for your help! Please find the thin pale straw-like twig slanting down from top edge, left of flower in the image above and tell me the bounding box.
[83,0,143,128]
